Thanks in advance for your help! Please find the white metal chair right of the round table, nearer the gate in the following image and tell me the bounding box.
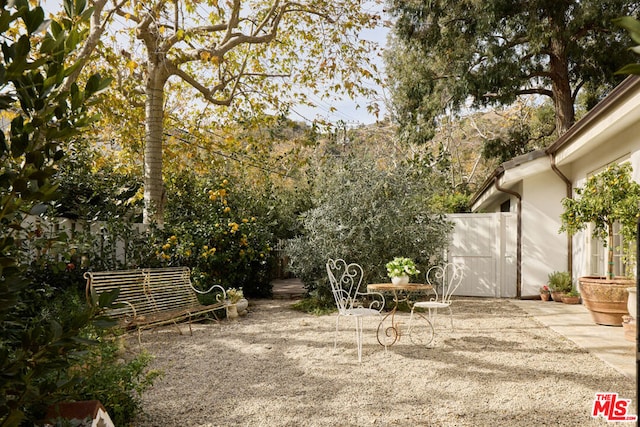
[409,263,464,330]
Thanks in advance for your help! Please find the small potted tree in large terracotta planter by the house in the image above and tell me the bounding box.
[560,164,640,326]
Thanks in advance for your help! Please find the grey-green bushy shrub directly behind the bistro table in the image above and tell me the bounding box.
[286,151,452,304]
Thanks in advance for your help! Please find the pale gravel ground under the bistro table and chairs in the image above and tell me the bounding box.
[130,298,636,426]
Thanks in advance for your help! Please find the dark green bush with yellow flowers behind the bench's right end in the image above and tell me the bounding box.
[156,174,272,297]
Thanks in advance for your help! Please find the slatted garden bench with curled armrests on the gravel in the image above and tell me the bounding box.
[84,267,227,334]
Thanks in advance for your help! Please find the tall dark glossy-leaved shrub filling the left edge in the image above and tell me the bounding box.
[0,0,160,426]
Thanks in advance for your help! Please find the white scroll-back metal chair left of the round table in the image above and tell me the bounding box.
[327,259,384,362]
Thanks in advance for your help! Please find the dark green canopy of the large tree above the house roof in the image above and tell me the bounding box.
[386,0,638,144]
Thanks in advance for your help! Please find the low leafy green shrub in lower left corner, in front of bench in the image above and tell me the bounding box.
[0,283,160,425]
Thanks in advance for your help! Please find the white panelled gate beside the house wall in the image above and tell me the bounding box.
[447,213,517,298]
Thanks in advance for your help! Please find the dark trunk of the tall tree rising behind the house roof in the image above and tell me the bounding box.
[550,32,575,136]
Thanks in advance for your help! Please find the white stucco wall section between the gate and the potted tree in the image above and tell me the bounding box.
[521,170,568,297]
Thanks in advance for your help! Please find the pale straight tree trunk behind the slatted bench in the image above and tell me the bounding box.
[144,64,167,225]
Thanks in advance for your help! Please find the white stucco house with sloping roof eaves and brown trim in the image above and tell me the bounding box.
[473,77,640,297]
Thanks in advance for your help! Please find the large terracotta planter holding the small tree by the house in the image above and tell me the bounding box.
[579,276,635,326]
